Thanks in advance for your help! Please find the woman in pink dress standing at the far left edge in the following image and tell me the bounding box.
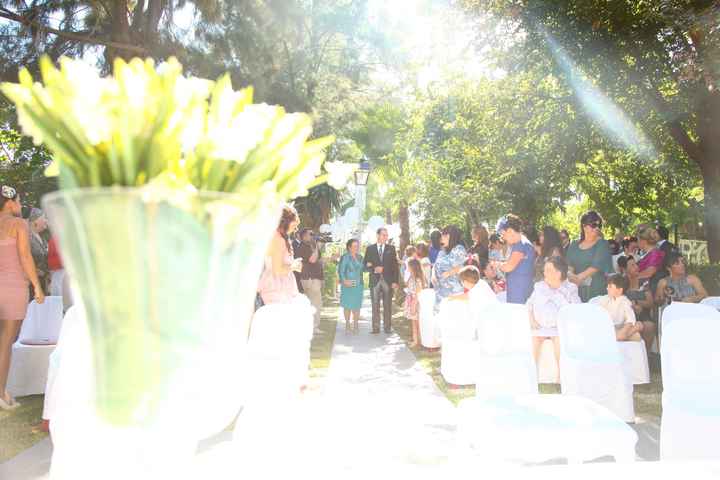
[0,185,45,410]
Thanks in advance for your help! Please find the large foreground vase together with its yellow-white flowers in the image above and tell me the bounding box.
[1,58,342,478]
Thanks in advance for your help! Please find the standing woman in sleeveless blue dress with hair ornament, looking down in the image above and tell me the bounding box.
[496,214,535,303]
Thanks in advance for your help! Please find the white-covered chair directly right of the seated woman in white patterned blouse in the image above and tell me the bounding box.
[558,303,635,422]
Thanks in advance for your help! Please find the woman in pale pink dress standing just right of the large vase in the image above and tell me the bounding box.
[258,205,302,304]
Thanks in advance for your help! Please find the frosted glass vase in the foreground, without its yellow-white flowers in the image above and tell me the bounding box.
[43,188,281,478]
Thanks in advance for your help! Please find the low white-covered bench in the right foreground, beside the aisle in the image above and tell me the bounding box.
[458,394,637,463]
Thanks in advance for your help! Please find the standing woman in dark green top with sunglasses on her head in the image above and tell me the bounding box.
[567,210,613,302]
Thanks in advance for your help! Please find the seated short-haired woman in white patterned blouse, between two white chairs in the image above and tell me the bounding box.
[527,257,581,382]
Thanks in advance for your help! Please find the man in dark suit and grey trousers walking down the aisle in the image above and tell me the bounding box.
[365,228,399,333]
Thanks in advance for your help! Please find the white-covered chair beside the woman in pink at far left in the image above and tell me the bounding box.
[7,296,63,397]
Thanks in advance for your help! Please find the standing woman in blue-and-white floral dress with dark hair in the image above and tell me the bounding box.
[433,225,468,308]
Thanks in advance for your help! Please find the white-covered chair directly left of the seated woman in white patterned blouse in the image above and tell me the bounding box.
[475,303,537,397]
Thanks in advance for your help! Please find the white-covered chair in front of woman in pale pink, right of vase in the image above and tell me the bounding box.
[247,295,314,401]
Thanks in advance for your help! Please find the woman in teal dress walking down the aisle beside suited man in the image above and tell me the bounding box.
[338,239,365,333]
